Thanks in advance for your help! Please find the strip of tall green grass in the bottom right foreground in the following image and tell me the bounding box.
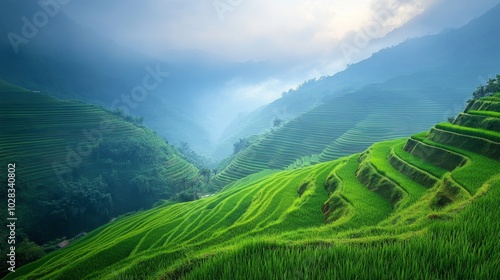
[184,179,500,279]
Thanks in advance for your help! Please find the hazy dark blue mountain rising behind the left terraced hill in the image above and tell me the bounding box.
[0,0,217,154]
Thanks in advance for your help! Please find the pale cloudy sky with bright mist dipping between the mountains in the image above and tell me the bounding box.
[63,0,500,137]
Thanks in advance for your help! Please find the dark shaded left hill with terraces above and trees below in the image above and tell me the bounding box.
[0,81,198,245]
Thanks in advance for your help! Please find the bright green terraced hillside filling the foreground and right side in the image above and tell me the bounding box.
[6,94,500,279]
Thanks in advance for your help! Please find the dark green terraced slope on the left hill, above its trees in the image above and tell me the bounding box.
[0,84,196,185]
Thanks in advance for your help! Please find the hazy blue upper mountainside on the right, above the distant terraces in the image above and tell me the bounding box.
[214,2,500,158]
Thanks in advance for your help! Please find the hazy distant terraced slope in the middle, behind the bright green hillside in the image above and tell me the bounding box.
[211,91,443,188]
